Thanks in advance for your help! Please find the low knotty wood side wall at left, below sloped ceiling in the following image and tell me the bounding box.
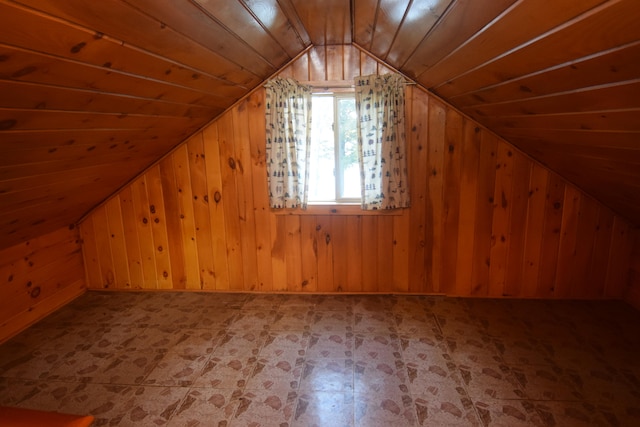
[0,228,86,343]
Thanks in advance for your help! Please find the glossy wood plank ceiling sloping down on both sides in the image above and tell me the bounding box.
[0,0,640,248]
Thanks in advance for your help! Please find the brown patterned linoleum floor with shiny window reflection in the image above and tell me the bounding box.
[0,292,640,427]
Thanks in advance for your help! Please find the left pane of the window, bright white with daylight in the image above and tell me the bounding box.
[309,95,336,202]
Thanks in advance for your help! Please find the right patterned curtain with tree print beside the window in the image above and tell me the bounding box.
[355,74,410,210]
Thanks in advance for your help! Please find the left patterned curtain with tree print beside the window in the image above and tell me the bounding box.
[265,77,311,209]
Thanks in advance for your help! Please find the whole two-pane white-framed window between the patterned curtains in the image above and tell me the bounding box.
[309,93,362,204]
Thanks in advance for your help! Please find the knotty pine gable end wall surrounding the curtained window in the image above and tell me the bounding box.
[81,45,631,298]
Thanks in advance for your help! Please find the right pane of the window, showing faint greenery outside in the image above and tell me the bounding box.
[337,97,361,199]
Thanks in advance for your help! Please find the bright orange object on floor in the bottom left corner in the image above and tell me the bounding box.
[0,406,93,427]
